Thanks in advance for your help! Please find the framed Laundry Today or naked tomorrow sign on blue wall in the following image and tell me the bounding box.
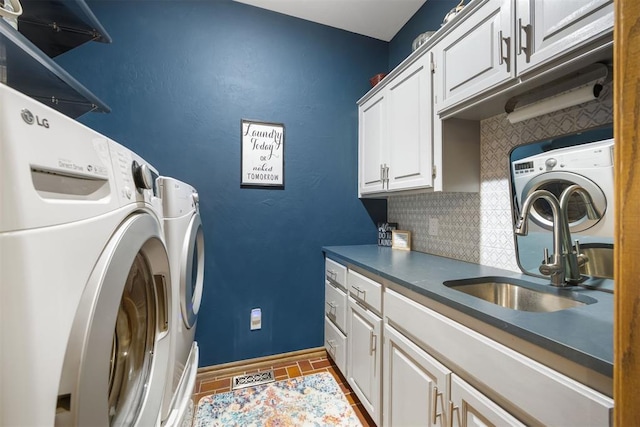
[240,119,284,189]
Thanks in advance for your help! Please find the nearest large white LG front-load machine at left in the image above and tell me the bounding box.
[0,85,171,426]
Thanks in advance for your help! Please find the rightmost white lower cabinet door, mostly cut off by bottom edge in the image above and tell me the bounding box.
[449,374,524,427]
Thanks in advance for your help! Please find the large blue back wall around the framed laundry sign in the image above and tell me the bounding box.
[57,0,388,366]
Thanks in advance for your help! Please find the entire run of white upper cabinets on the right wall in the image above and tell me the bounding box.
[358,0,613,197]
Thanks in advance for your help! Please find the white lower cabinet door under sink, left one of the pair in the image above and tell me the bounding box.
[382,324,451,427]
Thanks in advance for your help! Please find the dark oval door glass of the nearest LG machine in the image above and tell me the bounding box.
[109,253,156,425]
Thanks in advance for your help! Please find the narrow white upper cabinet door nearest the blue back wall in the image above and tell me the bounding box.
[358,90,386,195]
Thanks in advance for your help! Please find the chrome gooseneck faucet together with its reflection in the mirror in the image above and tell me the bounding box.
[515,184,602,286]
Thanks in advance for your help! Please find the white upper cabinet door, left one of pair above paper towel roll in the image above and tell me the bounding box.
[434,0,515,113]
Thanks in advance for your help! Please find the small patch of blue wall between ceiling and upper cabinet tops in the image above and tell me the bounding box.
[388,0,462,70]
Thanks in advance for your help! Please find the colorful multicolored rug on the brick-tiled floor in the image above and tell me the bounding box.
[193,372,362,427]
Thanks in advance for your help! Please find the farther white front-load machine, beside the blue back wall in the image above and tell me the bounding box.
[158,177,204,426]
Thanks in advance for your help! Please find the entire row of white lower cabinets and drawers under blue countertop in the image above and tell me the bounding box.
[325,260,613,427]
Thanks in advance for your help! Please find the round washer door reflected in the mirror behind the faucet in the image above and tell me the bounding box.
[520,172,607,233]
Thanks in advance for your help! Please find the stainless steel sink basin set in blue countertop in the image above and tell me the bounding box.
[444,277,597,312]
